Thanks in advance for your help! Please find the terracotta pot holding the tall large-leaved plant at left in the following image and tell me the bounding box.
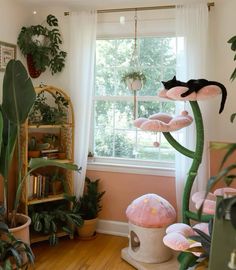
[9,214,31,245]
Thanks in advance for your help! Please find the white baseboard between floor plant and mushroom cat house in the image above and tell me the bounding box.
[97,219,129,237]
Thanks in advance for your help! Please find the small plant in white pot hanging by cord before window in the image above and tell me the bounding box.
[121,10,146,119]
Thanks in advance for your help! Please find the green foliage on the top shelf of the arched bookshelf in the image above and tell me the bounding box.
[29,91,69,125]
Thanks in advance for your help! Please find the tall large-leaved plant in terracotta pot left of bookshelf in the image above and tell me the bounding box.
[0,60,79,247]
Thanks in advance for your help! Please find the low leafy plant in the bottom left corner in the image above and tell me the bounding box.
[0,207,34,270]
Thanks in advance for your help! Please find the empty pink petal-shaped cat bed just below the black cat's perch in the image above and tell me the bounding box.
[134,111,193,132]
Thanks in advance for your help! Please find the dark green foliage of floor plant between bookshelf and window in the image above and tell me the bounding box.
[78,177,105,220]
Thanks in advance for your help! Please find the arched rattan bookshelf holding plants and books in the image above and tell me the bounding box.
[21,86,74,243]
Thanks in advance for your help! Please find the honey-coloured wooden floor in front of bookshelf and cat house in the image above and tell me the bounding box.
[32,234,135,270]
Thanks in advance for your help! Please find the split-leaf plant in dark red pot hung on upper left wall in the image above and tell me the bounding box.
[17,14,66,78]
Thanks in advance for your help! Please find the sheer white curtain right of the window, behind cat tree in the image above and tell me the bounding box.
[176,0,208,220]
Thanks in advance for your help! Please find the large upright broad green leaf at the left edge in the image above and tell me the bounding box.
[2,60,36,125]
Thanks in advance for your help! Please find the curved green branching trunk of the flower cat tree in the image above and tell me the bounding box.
[163,101,211,224]
